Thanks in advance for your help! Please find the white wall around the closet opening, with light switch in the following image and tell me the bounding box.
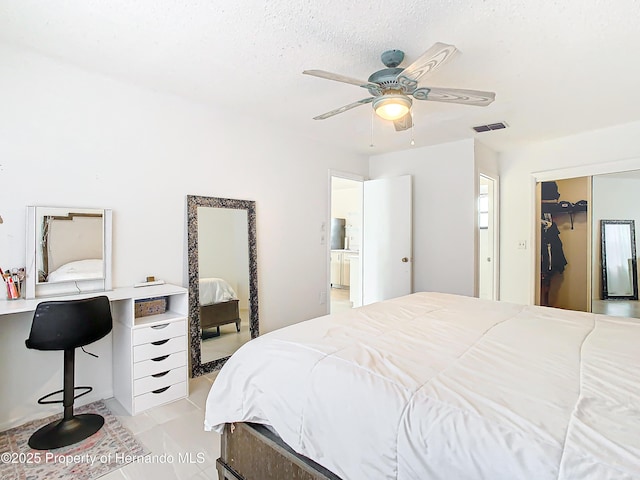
[500,122,640,304]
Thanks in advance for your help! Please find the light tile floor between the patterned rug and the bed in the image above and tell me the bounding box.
[100,372,220,480]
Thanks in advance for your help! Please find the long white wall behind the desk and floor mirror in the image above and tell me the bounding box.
[0,45,367,426]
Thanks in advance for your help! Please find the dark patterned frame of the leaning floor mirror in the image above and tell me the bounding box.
[187,195,259,377]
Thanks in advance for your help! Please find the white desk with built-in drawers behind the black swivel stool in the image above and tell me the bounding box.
[0,284,189,430]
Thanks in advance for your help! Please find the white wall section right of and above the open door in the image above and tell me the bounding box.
[369,140,477,295]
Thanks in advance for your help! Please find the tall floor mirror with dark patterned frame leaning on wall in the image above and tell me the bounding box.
[187,195,259,377]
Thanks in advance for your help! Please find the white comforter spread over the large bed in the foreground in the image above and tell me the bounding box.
[205,293,640,480]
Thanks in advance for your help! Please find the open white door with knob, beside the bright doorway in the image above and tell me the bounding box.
[362,175,413,305]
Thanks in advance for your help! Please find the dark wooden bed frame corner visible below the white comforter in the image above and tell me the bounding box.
[216,423,341,480]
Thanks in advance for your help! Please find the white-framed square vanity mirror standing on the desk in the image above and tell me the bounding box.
[25,206,112,298]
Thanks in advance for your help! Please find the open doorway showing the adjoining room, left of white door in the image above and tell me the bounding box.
[329,173,363,313]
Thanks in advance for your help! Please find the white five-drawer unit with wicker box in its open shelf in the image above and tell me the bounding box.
[112,285,189,415]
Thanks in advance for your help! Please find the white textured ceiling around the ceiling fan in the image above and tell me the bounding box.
[0,0,640,154]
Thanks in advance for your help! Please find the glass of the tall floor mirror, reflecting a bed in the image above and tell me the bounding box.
[198,207,251,363]
